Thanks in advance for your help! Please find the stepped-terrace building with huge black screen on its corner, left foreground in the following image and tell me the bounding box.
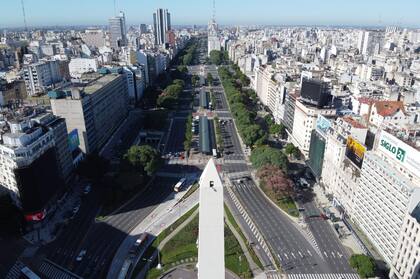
[0,108,73,221]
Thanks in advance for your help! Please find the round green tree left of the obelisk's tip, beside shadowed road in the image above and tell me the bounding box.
[124,145,162,176]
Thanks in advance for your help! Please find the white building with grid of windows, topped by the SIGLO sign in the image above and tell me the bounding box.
[352,131,420,264]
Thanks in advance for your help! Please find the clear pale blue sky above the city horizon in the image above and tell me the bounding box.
[0,0,420,29]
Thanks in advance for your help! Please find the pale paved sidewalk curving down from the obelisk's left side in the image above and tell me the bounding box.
[107,182,199,279]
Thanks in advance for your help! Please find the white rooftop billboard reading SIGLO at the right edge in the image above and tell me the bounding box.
[378,131,420,173]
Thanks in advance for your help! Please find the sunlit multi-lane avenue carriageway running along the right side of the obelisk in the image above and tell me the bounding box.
[206,66,358,278]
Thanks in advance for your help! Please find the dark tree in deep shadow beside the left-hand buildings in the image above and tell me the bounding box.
[76,153,109,182]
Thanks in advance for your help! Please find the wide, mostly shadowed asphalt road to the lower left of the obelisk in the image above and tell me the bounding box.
[36,177,177,278]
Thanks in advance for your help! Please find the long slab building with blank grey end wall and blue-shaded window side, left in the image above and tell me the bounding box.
[48,69,128,154]
